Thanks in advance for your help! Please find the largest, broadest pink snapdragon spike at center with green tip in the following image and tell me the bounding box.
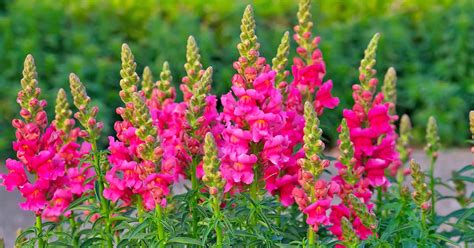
[218,6,303,202]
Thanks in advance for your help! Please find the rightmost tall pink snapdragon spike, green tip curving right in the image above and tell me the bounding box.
[343,34,399,187]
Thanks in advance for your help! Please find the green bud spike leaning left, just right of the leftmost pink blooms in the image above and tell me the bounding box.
[69,73,103,142]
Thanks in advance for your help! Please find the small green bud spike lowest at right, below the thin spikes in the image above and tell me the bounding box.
[410,159,432,211]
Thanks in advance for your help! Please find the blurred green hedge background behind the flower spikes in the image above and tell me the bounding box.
[0,0,474,157]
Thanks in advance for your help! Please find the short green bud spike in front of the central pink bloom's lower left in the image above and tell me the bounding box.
[203,133,225,195]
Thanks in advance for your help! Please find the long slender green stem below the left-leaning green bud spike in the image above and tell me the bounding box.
[91,138,113,248]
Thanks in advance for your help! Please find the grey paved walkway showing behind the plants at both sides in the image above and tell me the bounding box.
[0,149,474,247]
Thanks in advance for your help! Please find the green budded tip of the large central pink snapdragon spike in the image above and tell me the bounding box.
[237,5,260,68]
